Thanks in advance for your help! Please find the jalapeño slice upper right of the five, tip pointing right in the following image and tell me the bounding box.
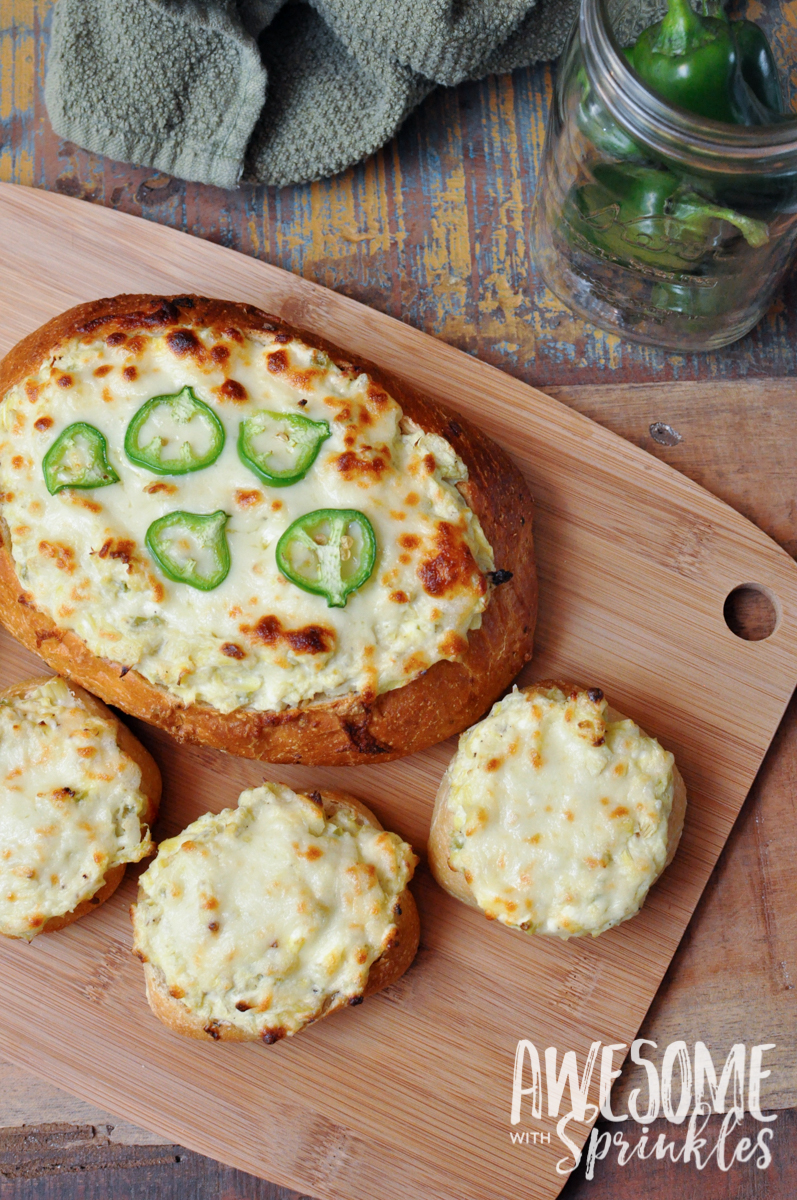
[238,408,330,487]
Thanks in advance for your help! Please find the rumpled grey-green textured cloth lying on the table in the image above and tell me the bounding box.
[46,0,577,187]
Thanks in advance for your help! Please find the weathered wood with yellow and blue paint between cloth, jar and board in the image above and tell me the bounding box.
[0,0,797,386]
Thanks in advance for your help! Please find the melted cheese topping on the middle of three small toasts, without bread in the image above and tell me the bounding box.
[133,784,418,1040]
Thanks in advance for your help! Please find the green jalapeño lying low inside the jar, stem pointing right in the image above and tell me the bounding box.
[564,163,768,272]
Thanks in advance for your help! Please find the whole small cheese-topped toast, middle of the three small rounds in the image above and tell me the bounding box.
[131,785,420,1045]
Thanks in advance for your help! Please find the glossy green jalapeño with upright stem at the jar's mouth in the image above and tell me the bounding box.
[627,0,767,125]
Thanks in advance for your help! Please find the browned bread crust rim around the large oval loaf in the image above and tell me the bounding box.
[0,295,537,766]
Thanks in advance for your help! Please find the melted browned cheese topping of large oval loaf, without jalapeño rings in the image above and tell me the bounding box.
[0,329,495,713]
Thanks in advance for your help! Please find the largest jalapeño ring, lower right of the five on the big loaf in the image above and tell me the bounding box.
[276,509,377,608]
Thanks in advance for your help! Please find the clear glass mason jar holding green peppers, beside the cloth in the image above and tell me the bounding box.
[535,0,797,350]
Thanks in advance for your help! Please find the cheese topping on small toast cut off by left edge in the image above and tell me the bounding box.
[0,678,152,941]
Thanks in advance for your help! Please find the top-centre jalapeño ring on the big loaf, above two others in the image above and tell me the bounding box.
[125,388,224,475]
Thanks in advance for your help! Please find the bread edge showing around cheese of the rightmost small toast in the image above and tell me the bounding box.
[426,679,687,921]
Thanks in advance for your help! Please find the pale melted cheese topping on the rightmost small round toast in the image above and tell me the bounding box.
[448,688,673,937]
